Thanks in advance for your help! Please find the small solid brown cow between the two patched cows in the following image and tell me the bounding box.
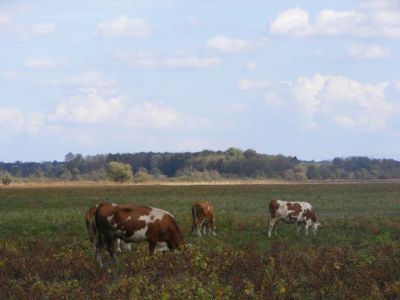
[192,201,216,237]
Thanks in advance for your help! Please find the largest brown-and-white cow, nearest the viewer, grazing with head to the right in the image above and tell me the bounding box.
[96,203,185,266]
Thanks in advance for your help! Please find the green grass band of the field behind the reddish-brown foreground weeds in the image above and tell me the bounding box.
[0,183,400,249]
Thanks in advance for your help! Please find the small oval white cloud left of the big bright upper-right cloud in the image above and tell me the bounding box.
[207,36,254,53]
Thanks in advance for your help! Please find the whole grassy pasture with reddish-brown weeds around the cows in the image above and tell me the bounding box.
[0,182,400,299]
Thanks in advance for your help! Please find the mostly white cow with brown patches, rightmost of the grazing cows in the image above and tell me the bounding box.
[268,200,321,237]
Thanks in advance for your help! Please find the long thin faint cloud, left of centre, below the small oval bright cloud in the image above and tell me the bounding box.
[116,52,221,69]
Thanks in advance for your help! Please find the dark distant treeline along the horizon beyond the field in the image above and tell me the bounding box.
[0,148,400,180]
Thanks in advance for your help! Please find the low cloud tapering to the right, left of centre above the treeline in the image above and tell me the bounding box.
[124,102,208,130]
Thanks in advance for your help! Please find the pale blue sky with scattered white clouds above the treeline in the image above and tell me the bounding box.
[0,0,400,162]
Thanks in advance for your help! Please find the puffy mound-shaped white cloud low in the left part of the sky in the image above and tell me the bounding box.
[51,89,125,124]
